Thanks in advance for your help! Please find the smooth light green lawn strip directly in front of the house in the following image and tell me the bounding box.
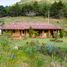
[13,38,67,48]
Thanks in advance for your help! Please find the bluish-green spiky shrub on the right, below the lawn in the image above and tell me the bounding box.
[40,43,59,56]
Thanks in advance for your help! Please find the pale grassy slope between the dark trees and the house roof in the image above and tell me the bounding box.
[0,16,67,27]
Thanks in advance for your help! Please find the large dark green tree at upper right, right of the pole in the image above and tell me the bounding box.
[50,1,64,18]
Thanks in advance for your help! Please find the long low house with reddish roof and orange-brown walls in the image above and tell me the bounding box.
[1,22,62,38]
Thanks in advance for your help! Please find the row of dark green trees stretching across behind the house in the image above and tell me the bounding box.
[0,1,67,18]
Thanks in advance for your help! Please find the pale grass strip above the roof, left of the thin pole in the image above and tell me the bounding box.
[0,16,55,23]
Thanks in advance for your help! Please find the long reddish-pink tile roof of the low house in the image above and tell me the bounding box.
[3,23,61,30]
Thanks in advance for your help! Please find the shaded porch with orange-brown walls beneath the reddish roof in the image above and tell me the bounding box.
[8,30,59,39]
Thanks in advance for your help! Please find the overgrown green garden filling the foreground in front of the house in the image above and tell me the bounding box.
[0,35,67,67]
